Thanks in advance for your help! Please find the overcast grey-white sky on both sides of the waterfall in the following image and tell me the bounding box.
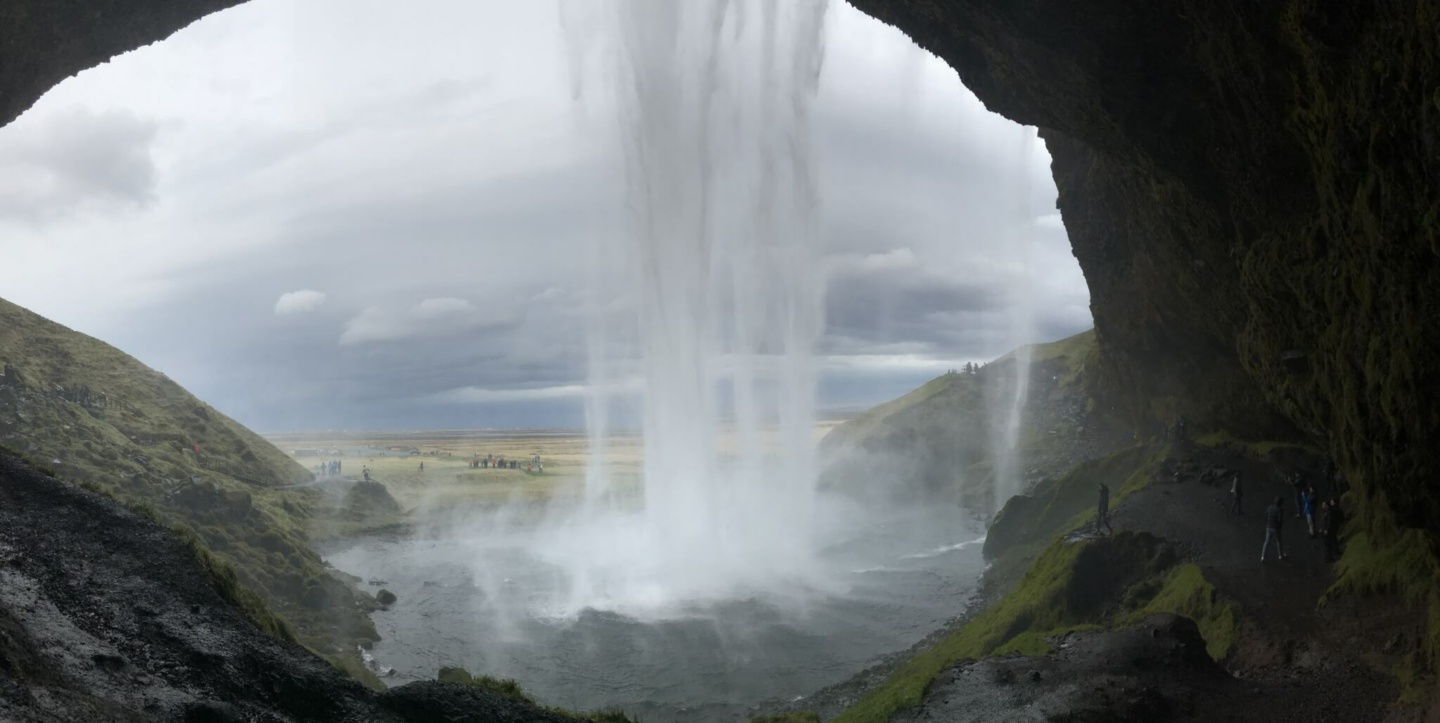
[0,0,1090,431]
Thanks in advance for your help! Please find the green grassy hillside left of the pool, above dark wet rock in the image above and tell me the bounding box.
[0,300,374,674]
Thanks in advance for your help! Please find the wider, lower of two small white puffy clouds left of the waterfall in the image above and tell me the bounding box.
[340,297,520,346]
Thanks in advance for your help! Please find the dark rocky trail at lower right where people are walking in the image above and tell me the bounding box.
[897,445,1420,723]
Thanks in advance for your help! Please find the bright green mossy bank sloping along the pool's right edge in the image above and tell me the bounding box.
[835,531,1166,723]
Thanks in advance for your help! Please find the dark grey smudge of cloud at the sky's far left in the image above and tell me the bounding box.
[0,107,158,222]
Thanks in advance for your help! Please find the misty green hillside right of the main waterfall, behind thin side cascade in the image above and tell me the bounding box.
[821,331,1129,513]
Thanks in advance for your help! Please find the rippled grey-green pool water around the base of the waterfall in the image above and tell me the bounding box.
[328,507,984,720]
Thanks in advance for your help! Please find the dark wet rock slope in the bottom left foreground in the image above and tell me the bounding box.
[0,455,584,722]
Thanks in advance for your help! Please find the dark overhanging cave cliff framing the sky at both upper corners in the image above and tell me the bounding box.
[0,0,1440,576]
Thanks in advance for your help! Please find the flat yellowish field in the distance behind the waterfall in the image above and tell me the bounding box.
[268,422,838,508]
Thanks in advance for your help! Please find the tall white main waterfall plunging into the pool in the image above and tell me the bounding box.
[552,0,827,608]
